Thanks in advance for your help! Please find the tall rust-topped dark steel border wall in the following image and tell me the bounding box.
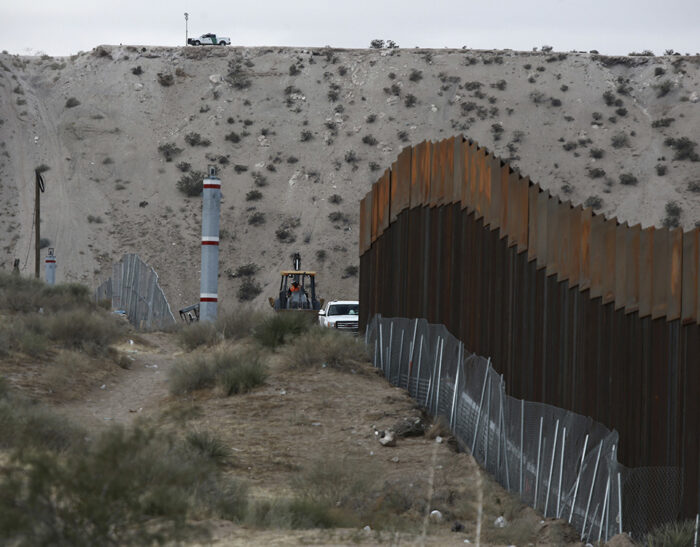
[360,136,700,516]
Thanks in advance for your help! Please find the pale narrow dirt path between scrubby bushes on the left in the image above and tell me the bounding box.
[60,333,179,431]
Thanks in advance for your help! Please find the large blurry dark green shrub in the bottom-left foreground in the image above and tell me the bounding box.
[0,427,247,545]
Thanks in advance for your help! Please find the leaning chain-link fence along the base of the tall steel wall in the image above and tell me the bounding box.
[365,315,682,541]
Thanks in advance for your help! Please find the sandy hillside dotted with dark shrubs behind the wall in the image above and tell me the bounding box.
[0,46,700,310]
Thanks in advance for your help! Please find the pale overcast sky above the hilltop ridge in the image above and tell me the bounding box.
[0,0,700,55]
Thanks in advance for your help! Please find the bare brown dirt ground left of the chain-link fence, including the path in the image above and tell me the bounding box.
[2,333,575,545]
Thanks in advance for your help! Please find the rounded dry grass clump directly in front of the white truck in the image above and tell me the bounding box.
[284,326,368,371]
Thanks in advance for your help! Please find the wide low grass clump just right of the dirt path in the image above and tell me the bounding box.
[168,346,267,396]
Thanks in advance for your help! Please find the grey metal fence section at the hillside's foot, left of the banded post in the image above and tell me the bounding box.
[95,254,175,329]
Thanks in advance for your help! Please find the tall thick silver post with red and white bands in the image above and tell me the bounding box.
[199,166,221,321]
